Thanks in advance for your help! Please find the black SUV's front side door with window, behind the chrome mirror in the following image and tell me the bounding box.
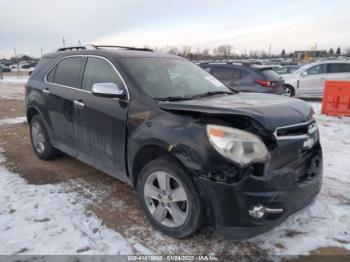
[74,57,128,179]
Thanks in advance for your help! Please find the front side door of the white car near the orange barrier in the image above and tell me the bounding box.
[299,64,328,96]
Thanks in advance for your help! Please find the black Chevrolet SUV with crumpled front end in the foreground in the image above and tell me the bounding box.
[26,46,322,239]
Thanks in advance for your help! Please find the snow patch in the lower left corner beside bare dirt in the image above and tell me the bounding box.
[0,148,142,255]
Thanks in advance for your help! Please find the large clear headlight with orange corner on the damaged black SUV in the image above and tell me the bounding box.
[207,125,269,166]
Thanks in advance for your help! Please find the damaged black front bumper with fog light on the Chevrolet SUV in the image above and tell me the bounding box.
[196,143,322,239]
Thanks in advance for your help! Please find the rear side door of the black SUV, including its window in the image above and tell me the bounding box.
[43,57,83,156]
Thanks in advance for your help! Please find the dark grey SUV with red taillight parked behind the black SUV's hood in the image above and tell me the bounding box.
[200,63,284,95]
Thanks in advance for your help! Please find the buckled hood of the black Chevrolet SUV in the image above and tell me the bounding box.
[159,93,314,131]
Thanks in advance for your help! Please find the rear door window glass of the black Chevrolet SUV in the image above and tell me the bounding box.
[53,57,83,87]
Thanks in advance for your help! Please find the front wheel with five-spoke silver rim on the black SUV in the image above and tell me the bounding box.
[137,157,204,238]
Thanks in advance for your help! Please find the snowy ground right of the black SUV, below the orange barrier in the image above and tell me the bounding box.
[252,102,350,255]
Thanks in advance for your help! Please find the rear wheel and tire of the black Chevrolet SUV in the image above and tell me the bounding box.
[29,115,60,160]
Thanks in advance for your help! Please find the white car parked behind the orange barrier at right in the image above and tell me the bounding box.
[282,60,350,97]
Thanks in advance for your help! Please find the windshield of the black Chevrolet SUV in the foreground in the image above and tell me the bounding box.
[120,58,231,99]
